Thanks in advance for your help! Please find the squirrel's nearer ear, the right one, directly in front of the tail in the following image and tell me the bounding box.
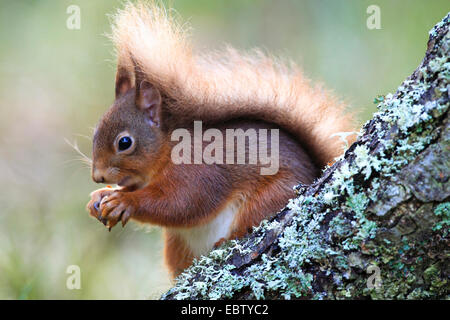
[136,80,162,127]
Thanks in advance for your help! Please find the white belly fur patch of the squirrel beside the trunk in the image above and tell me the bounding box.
[172,201,240,257]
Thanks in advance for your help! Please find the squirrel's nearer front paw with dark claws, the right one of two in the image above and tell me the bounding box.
[99,192,136,229]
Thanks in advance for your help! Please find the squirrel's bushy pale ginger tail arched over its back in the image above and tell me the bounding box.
[112,2,352,166]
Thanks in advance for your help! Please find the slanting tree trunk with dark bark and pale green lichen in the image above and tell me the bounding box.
[162,14,450,299]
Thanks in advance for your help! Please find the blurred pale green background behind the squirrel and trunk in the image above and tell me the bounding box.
[0,0,450,299]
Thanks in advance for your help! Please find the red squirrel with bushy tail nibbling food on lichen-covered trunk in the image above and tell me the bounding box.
[87,3,352,276]
